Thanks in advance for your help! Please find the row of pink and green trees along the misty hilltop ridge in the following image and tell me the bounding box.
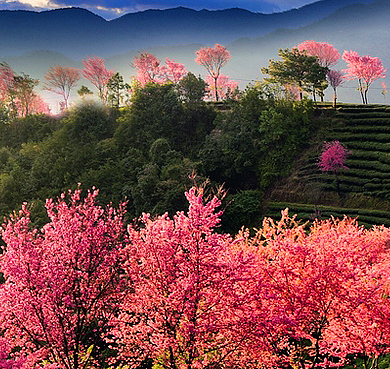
[0,40,386,116]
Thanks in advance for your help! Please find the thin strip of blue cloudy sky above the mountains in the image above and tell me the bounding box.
[0,0,316,20]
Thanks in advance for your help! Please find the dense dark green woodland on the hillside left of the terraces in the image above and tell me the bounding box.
[0,80,318,230]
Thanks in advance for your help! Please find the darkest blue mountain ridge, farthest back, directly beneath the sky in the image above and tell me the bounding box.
[0,0,373,59]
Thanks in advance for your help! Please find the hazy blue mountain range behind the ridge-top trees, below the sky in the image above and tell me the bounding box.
[0,0,390,107]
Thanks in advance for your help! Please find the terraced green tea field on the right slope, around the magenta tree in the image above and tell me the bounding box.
[265,105,390,226]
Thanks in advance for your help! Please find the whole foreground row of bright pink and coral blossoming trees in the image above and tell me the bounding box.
[0,188,390,369]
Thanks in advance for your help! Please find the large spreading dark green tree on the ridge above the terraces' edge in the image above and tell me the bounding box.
[261,48,329,99]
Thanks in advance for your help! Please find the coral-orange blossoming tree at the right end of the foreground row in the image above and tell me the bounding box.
[253,209,390,369]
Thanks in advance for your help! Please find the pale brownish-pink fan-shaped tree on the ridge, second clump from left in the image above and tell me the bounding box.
[44,65,80,109]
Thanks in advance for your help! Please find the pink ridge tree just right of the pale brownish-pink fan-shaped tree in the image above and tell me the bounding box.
[82,56,115,103]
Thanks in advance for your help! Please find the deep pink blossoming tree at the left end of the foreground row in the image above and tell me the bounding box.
[0,190,126,369]
